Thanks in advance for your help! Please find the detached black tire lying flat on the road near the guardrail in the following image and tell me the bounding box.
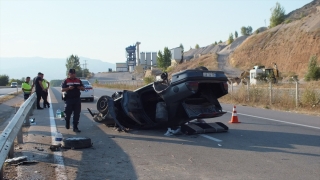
[61,137,92,149]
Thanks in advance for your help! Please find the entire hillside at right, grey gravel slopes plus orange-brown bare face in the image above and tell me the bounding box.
[170,0,320,79]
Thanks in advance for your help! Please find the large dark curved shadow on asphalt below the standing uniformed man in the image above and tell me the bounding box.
[34,88,138,180]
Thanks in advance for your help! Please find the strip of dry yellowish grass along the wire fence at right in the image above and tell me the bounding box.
[219,84,320,115]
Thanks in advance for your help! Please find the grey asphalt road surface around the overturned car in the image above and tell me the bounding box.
[5,88,320,180]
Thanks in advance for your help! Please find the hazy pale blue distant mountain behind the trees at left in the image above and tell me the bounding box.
[0,57,116,80]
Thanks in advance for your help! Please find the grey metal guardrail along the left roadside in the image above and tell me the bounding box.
[0,93,36,180]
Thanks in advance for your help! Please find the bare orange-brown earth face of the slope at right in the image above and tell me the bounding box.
[229,12,320,78]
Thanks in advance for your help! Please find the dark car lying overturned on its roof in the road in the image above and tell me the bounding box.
[88,67,228,133]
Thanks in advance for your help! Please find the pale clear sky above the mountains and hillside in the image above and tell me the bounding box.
[0,0,311,63]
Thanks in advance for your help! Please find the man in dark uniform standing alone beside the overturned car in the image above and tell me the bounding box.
[61,69,85,132]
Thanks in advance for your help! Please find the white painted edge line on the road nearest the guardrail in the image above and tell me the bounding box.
[48,92,68,180]
